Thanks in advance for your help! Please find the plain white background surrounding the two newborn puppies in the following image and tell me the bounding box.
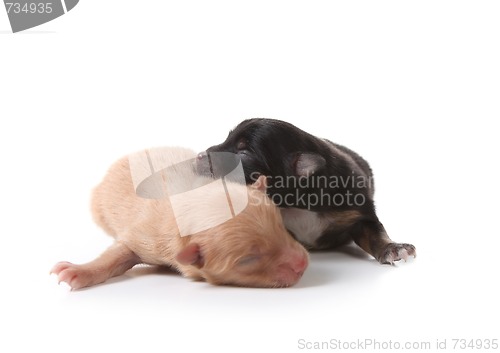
[0,0,500,352]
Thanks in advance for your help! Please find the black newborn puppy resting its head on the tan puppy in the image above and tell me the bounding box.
[198,119,416,264]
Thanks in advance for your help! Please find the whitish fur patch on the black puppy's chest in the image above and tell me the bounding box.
[280,208,331,247]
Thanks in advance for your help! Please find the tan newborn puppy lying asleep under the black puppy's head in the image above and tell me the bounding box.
[51,148,308,289]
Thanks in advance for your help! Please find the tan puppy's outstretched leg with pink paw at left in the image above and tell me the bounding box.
[51,243,141,289]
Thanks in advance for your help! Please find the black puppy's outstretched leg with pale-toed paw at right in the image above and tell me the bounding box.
[351,221,417,264]
